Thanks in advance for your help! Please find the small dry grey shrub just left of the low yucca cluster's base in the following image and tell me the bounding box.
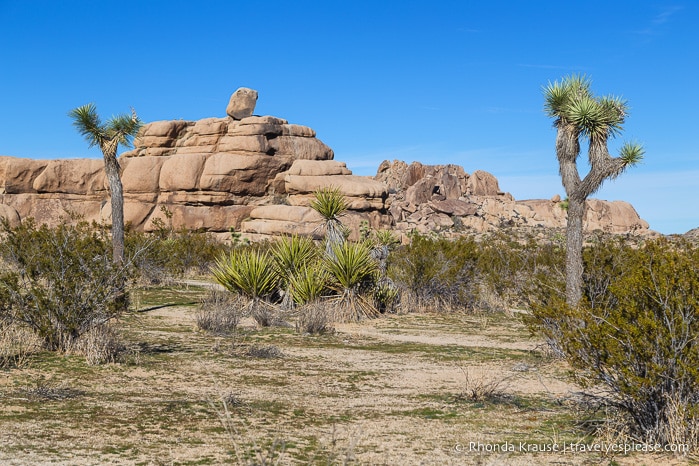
[195,290,249,335]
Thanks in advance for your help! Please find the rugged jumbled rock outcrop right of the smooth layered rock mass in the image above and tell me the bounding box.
[376,161,648,240]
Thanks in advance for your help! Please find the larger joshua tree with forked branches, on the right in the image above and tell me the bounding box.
[544,75,644,307]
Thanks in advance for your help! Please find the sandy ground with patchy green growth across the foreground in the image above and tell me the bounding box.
[0,307,686,465]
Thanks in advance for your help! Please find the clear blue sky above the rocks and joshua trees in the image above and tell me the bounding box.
[0,0,699,233]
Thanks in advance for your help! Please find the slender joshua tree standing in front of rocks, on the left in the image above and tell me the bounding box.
[68,104,142,265]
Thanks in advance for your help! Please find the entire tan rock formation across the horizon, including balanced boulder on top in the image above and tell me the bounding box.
[0,88,648,239]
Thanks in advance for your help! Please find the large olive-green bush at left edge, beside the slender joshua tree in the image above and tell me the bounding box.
[0,221,130,350]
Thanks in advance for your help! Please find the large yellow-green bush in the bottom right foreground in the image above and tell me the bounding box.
[529,240,699,447]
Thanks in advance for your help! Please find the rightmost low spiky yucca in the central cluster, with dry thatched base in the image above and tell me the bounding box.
[324,242,379,321]
